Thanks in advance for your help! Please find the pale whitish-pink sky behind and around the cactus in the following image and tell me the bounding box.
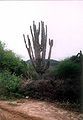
[0,1,83,60]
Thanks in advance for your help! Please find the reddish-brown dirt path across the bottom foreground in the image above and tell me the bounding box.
[0,99,81,120]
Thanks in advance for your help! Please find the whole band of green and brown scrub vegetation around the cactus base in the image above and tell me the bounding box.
[0,42,81,112]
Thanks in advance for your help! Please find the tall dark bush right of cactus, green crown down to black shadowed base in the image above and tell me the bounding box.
[52,57,81,103]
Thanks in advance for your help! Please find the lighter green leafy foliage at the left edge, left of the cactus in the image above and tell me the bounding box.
[0,41,27,98]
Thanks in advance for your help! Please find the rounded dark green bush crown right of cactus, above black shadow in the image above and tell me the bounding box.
[57,59,80,79]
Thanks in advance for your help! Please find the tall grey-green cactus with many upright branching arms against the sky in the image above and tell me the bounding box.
[23,21,53,75]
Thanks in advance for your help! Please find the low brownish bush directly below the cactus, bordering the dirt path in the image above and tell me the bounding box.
[21,80,64,100]
